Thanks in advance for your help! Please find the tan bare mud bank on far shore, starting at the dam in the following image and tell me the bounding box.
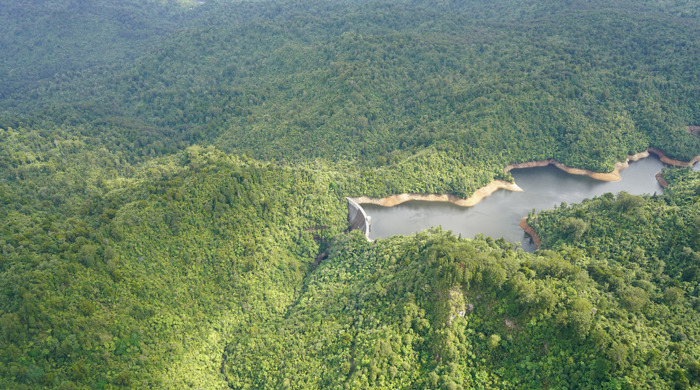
[352,180,523,207]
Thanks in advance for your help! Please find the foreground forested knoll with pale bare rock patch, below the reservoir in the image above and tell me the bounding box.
[226,230,644,388]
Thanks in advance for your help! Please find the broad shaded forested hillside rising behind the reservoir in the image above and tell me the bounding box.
[3,2,700,180]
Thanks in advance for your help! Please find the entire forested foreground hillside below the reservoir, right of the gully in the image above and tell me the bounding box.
[225,170,700,389]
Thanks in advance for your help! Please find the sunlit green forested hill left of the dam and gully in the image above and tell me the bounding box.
[0,129,344,388]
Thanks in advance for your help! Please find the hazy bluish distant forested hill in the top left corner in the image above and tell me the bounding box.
[0,0,202,98]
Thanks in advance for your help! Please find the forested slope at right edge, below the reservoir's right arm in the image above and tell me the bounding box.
[529,169,700,388]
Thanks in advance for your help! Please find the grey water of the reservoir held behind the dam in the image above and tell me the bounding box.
[362,155,668,251]
